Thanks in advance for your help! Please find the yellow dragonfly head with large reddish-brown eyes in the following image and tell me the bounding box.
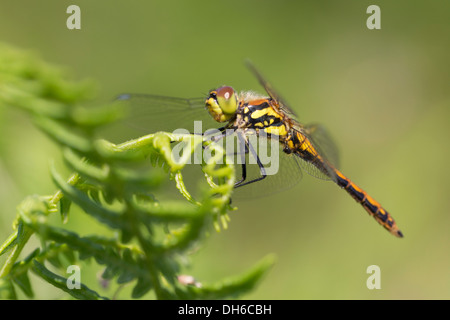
[206,86,239,122]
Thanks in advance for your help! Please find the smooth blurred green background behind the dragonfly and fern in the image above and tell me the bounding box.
[0,0,450,299]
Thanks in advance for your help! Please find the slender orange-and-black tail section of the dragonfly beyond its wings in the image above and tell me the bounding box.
[336,170,403,237]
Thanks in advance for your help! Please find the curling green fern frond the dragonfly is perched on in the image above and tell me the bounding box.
[0,45,273,299]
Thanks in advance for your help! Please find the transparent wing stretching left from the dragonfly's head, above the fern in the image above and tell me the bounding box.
[101,94,219,142]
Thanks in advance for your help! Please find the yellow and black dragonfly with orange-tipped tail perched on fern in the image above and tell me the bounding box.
[114,61,403,238]
